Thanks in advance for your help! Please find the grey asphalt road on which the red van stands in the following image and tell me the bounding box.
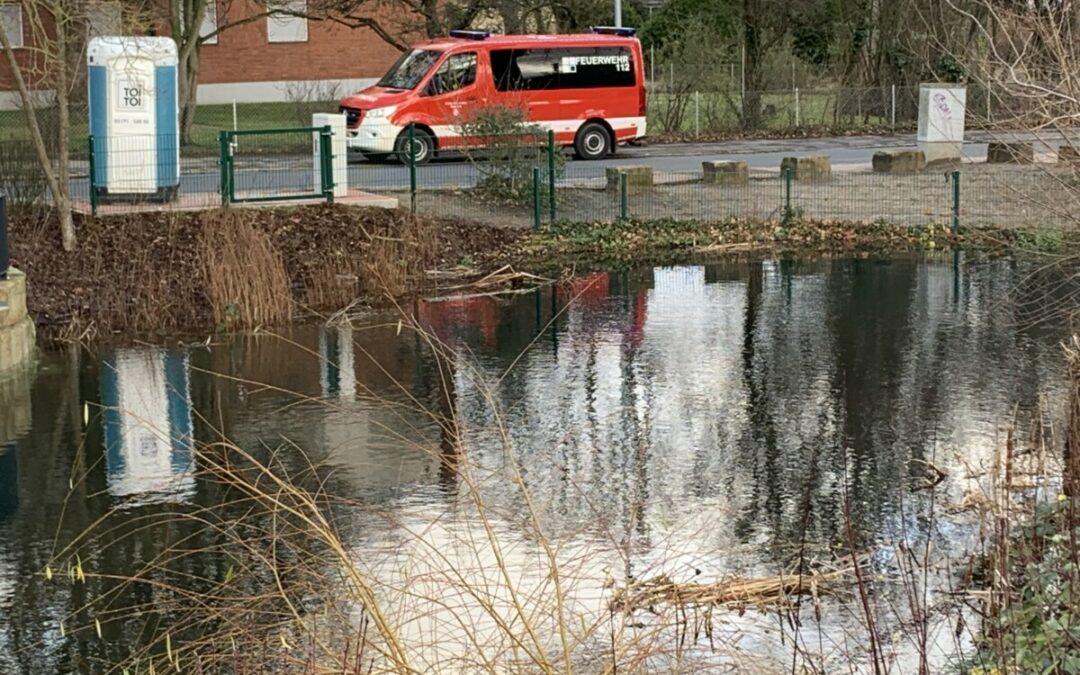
[72,132,1075,195]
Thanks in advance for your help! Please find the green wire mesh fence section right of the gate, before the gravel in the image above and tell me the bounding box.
[386,157,1080,228]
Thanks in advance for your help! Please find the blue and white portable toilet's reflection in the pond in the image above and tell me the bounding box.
[102,349,194,501]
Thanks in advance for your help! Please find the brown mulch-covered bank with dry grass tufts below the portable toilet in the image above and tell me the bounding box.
[11,205,519,339]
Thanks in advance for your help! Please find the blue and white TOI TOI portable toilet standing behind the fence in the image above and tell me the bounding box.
[86,37,180,201]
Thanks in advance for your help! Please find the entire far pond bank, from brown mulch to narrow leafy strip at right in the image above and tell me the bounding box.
[11,205,1036,340]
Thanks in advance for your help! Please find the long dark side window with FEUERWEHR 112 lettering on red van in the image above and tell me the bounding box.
[491,46,637,92]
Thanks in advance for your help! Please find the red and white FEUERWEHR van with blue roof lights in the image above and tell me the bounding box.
[340,28,645,163]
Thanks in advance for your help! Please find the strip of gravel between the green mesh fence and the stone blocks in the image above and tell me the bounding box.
[401,165,1080,227]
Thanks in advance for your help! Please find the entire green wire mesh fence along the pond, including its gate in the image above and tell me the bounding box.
[0,105,1080,227]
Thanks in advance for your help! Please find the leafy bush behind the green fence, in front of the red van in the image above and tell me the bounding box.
[459,106,566,205]
